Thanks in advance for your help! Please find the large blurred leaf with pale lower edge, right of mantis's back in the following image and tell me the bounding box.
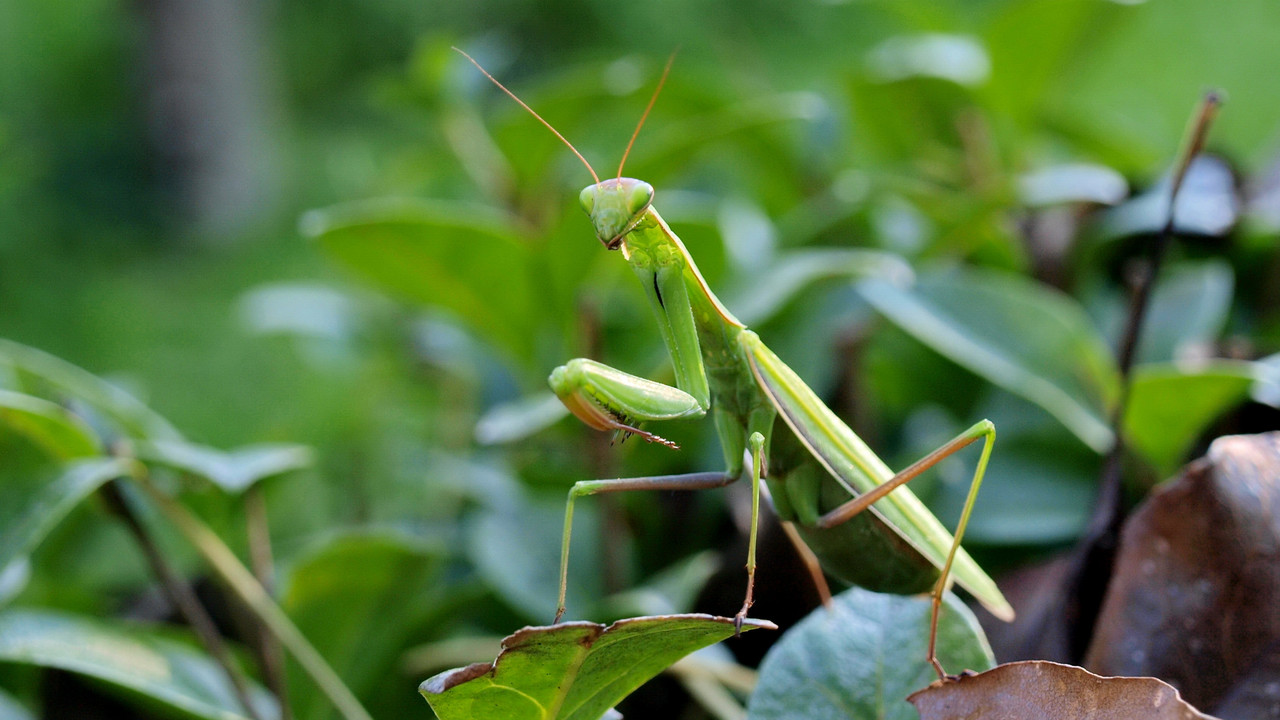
[859,270,1117,452]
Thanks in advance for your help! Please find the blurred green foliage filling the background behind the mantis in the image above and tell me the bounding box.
[0,0,1280,719]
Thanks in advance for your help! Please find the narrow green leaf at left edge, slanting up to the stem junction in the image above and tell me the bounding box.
[0,457,133,570]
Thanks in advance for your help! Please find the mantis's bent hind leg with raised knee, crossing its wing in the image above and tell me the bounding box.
[818,420,996,679]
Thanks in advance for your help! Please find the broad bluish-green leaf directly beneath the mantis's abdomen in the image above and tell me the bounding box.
[748,588,995,720]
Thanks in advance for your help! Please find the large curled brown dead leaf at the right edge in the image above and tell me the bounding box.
[1084,433,1280,707]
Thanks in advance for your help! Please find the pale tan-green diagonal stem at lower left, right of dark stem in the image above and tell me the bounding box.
[138,477,372,720]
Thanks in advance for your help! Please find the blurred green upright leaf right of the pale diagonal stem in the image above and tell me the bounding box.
[280,529,444,719]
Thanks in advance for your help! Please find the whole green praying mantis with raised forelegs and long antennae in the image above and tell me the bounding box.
[458,50,1014,678]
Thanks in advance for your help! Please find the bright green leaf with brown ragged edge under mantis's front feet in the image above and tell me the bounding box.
[419,615,776,720]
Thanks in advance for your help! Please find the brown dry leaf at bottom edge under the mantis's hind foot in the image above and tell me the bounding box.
[910,660,1210,720]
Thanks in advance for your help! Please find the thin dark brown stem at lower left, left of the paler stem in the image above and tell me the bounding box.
[99,480,262,720]
